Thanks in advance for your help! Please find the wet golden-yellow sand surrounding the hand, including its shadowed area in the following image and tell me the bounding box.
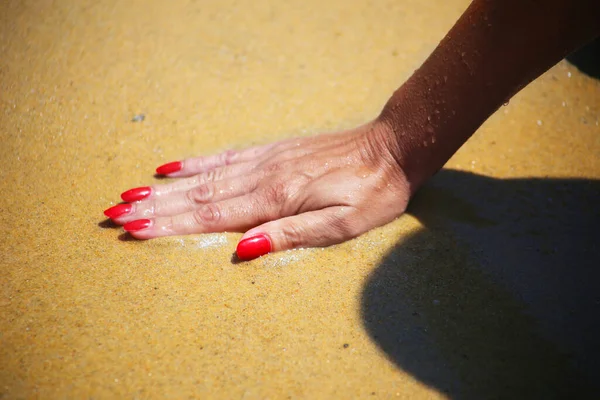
[0,0,600,399]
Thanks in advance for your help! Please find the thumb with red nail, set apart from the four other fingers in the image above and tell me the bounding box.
[236,206,367,260]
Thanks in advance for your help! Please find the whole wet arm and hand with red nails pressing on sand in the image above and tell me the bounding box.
[105,0,600,259]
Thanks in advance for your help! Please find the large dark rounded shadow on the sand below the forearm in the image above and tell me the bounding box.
[362,170,600,399]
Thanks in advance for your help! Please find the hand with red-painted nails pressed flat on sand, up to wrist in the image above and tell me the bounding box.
[105,122,410,259]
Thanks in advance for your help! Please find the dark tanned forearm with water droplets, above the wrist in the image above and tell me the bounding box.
[379,0,600,192]
